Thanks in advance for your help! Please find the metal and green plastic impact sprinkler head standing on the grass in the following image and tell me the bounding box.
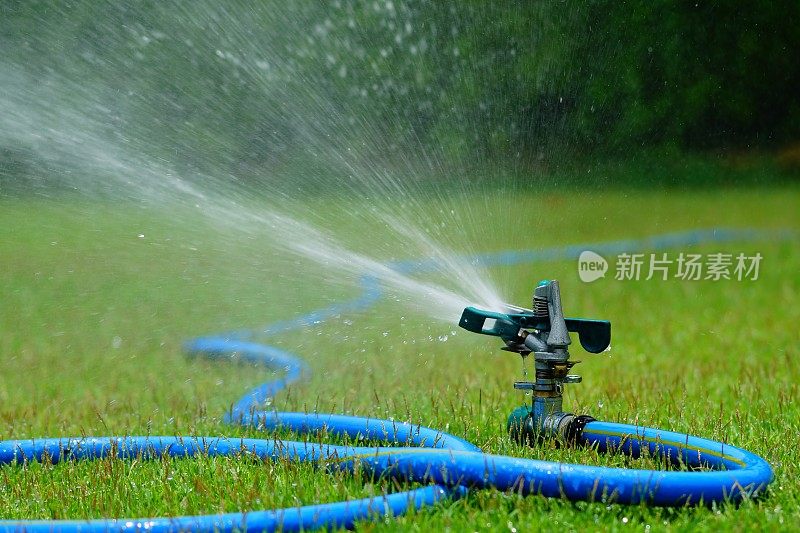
[459,280,611,444]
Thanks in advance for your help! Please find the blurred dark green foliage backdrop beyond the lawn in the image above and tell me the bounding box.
[0,0,800,192]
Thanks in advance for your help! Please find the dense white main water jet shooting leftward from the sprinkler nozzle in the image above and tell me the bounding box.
[0,70,499,322]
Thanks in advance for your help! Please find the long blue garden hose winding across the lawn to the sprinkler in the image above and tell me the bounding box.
[0,230,780,532]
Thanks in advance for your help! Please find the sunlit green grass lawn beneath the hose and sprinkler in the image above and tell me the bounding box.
[0,186,800,531]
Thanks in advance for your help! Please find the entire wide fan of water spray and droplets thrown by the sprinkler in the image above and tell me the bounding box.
[0,3,564,321]
